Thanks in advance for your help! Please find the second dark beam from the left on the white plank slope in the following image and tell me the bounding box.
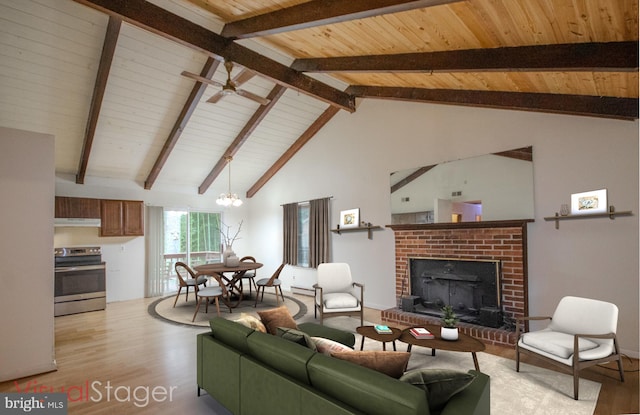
[144,57,220,190]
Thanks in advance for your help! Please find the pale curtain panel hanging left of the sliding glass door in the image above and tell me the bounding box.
[145,206,165,297]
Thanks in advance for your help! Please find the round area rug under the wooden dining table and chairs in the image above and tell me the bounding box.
[147,292,307,327]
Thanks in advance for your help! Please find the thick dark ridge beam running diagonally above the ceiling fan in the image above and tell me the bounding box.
[74,0,355,112]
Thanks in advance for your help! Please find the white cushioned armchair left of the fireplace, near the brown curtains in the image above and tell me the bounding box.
[313,262,364,326]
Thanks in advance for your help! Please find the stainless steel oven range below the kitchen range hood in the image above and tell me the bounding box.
[53,247,107,316]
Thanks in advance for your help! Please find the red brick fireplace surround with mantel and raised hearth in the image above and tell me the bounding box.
[382,220,532,345]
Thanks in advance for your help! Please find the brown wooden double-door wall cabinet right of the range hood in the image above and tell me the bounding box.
[100,199,144,236]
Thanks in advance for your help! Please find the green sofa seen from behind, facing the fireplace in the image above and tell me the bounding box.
[197,317,490,415]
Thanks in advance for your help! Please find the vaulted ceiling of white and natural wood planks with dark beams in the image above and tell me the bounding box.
[0,0,639,197]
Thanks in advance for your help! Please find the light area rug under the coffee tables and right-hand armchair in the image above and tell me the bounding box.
[310,314,601,415]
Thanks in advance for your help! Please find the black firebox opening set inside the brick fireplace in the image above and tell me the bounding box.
[402,258,502,327]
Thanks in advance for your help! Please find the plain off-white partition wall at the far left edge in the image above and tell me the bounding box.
[0,127,56,382]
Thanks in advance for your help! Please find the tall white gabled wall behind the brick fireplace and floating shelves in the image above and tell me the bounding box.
[249,100,639,356]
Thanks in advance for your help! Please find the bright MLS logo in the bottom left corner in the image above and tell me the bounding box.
[0,393,67,415]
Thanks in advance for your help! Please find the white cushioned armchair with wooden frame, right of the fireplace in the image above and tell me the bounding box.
[516,296,624,400]
